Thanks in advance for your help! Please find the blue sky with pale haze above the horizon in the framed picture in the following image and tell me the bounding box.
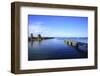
[28,15,88,37]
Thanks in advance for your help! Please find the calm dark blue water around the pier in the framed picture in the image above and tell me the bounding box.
[28,38,88,60]
